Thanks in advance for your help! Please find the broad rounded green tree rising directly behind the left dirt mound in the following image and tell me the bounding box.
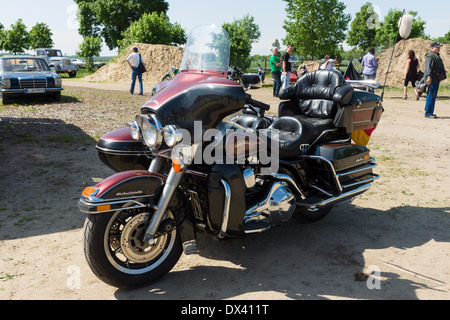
[119,12,187,48]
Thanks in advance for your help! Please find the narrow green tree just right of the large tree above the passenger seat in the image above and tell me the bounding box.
[347,2,380,50]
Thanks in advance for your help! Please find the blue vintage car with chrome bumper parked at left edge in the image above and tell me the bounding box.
[0,56,63,104]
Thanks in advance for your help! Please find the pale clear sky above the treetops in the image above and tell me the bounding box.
[0,0,450,56]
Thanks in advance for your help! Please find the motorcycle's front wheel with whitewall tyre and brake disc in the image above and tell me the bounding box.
[84,209,182,288]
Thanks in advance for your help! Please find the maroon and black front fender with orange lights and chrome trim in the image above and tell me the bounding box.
[78,170,166,214]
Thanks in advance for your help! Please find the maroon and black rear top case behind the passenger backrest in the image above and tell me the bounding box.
[334,90,383,133]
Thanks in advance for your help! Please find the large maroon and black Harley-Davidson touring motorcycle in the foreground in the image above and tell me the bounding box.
[78,25,383,287]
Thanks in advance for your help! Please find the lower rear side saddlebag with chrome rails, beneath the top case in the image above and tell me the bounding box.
[305,144,379,195]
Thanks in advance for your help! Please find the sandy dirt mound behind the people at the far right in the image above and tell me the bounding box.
[377,38,450,87]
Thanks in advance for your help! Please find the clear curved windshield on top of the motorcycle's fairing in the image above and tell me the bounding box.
[180,25,230,72]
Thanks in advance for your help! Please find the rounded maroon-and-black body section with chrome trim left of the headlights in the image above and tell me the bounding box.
[95,127,151,172]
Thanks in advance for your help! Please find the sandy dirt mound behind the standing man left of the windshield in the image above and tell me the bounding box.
[83,43,184,84]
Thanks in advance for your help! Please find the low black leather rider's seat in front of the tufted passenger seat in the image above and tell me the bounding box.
[264,115,334,158]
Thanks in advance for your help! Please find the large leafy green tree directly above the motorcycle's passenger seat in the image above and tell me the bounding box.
[283,0,351,57]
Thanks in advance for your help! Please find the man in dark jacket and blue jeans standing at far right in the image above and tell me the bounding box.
[424,42,447,119]
